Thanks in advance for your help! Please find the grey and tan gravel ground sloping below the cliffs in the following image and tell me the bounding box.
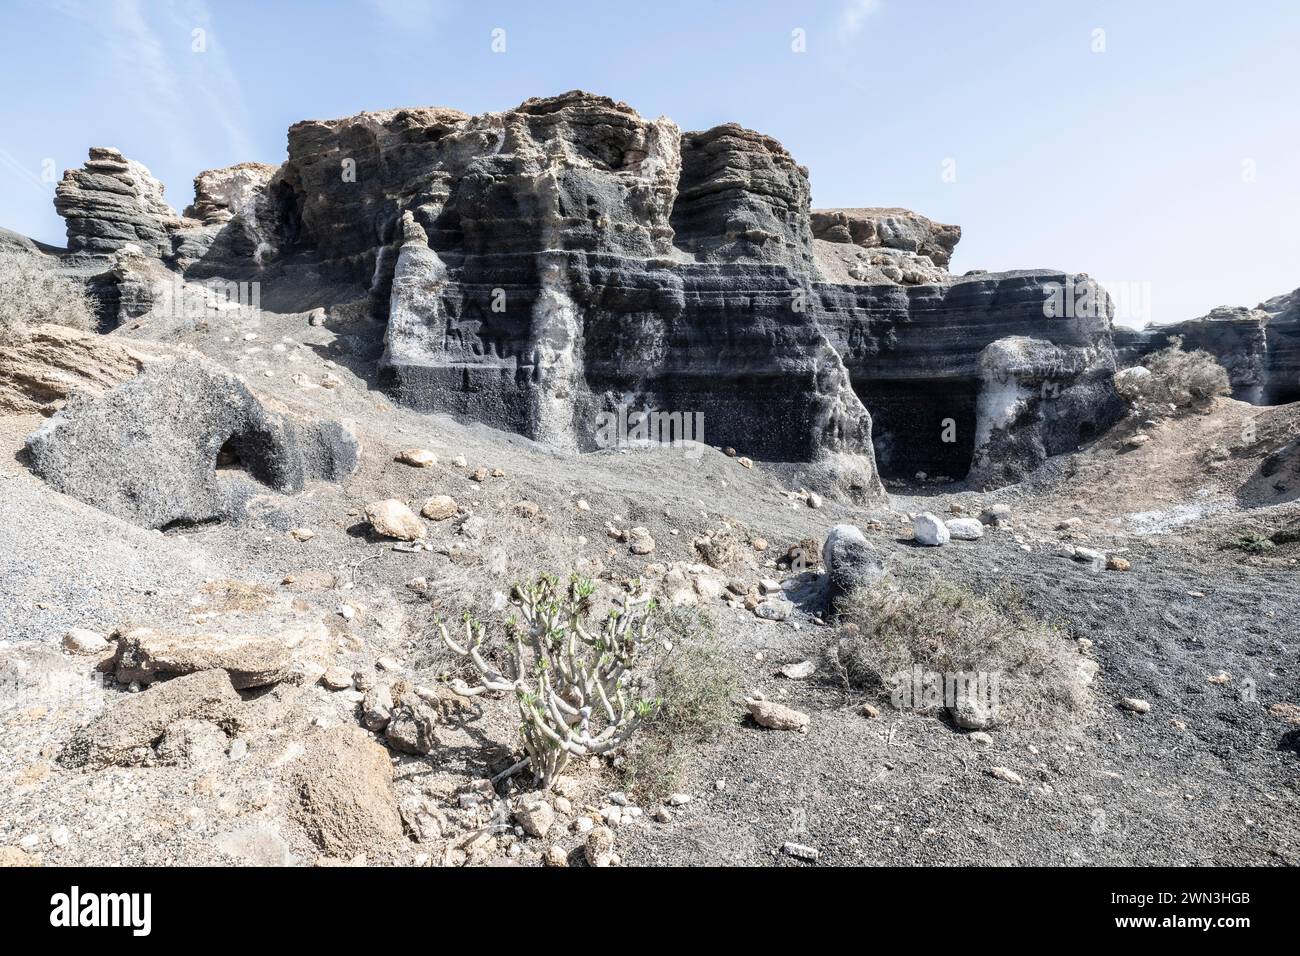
[0,304,1300,865]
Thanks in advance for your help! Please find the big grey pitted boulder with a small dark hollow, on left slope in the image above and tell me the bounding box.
[27,358,358,528]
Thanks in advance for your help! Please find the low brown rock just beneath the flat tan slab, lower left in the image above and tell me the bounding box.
[59,670,241,767]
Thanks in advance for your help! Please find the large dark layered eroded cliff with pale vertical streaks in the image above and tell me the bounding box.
[45,91,1119,498]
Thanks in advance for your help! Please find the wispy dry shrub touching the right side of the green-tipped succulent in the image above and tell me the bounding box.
[623,607,741,799]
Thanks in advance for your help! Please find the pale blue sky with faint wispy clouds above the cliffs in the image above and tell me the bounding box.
[0,0,1300,324]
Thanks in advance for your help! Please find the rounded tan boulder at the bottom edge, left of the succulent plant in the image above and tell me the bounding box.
[293,726,402,857]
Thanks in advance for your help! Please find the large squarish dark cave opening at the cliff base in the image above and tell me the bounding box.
[853,378,979,481]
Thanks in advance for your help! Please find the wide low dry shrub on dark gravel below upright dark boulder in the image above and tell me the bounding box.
[836,579,1089,727]
